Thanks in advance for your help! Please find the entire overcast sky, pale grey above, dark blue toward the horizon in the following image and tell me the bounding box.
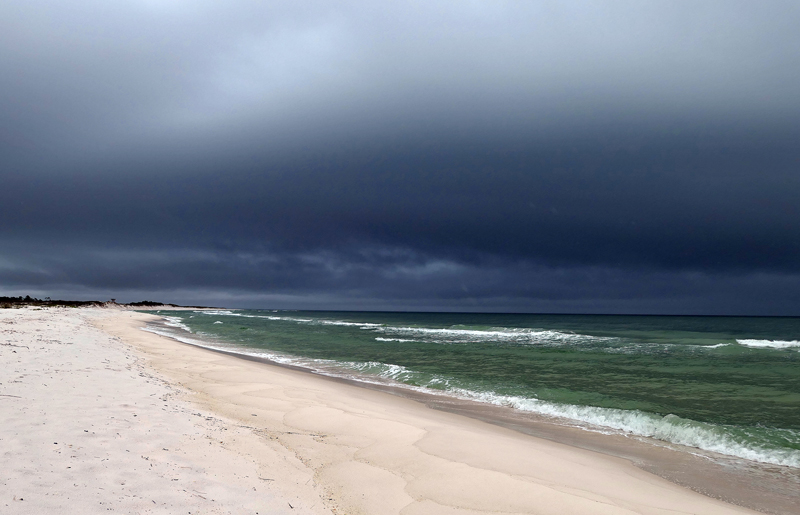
[0,0,800,315]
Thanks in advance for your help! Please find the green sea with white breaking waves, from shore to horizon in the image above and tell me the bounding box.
[145,310,800,468]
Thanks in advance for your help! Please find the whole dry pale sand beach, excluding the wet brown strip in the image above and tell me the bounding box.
[0,308,756,515]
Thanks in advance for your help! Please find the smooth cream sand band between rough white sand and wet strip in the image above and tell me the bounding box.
[106,308,764,513]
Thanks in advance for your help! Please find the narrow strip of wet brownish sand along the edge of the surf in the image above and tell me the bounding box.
[144,315,800,515]
